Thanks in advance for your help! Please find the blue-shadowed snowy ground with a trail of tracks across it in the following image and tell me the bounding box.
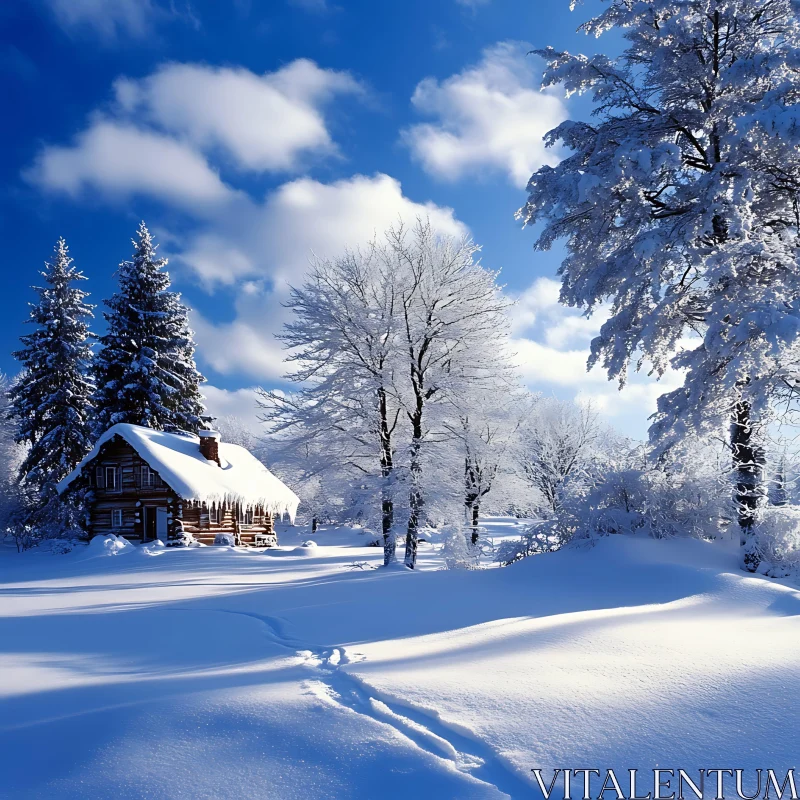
[0,520,800,800]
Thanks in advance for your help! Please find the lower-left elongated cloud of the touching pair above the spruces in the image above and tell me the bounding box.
[24,118,235,208]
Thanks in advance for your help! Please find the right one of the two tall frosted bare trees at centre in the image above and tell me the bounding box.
[382,220,512,569]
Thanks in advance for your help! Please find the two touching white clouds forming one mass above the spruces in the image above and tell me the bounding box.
[24,59,362,208]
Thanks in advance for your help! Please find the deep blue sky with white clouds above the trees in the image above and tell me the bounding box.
[0,0,676,435]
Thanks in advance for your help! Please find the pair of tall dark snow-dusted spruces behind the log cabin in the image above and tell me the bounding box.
[3,222,206,544]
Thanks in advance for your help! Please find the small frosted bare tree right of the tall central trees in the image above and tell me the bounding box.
[515,397,602,515]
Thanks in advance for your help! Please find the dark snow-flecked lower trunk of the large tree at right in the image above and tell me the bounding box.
[731,401,763,572]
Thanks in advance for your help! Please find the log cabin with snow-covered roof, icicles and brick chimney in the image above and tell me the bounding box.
[57,423,299,546]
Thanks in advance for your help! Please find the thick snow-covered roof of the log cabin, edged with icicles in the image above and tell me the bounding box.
[56,423,300,520]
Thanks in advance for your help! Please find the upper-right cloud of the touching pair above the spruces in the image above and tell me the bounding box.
[115,58,364,171]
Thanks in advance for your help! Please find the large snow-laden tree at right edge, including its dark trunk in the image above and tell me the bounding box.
[520,0,800,570]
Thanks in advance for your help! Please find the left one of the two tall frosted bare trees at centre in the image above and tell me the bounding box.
[261,242,400,565]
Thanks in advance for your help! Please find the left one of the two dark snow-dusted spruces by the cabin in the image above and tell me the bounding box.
[9,239,94,524]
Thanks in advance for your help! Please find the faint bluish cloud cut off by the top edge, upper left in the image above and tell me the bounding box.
[46,0,159,39]
